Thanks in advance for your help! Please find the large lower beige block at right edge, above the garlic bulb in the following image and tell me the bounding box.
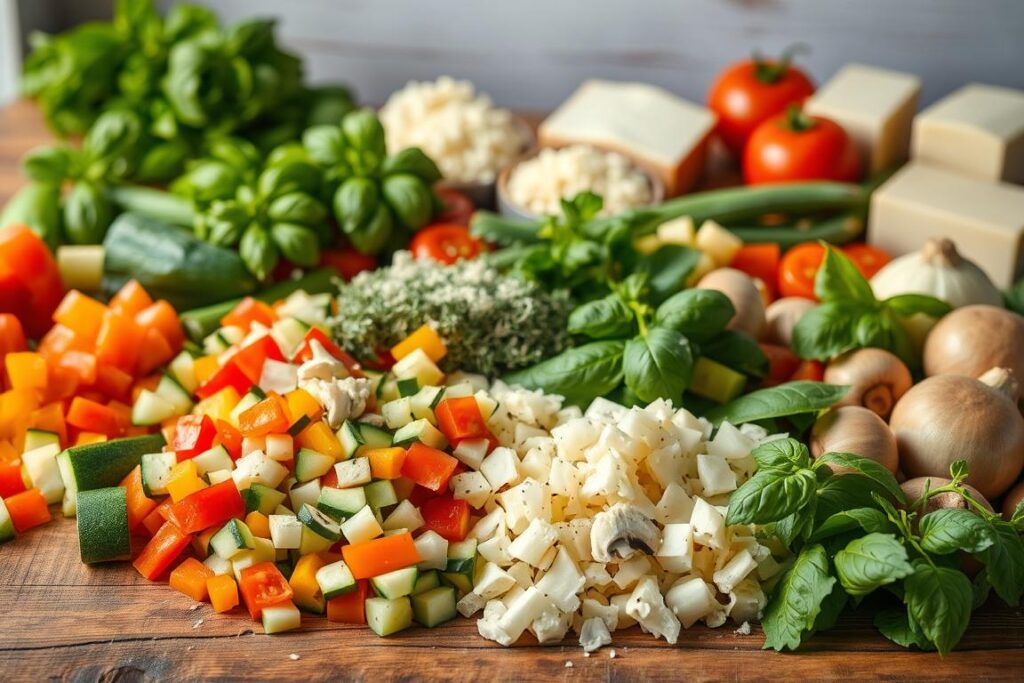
[867,162,1024,287]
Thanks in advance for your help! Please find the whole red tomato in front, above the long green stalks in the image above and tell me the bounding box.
[743,108,860,185]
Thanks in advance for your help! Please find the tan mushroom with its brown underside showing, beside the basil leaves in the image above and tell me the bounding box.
[824,348,913,419]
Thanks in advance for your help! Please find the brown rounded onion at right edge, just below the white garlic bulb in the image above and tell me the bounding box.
[924,304,1024,378]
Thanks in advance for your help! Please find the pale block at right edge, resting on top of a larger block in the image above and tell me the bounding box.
[911,83,1024,183]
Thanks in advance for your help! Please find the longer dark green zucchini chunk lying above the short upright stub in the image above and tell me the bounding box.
[57,434,165,517]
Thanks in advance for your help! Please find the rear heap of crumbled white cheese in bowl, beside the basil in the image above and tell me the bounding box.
[380,76,536,206]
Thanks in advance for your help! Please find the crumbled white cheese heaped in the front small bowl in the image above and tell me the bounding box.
[498,144,665,218]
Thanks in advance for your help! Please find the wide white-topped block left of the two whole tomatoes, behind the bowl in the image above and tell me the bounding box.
[538,80,716,196]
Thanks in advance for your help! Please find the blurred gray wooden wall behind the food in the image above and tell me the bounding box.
[9,0,1024,110]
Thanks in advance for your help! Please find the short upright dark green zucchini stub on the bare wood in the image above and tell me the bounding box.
[78,486,131,564]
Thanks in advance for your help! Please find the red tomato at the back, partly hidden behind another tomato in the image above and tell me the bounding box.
[708,51,814,156]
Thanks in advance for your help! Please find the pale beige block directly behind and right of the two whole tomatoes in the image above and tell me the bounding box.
[805,63,921,175]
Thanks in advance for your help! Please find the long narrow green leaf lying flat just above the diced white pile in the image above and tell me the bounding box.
[705,380,850,425]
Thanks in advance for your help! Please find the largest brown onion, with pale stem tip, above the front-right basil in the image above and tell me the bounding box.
[889,368,1024,499]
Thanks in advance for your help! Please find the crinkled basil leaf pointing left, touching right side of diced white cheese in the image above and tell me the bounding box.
[726,469,817,524]
